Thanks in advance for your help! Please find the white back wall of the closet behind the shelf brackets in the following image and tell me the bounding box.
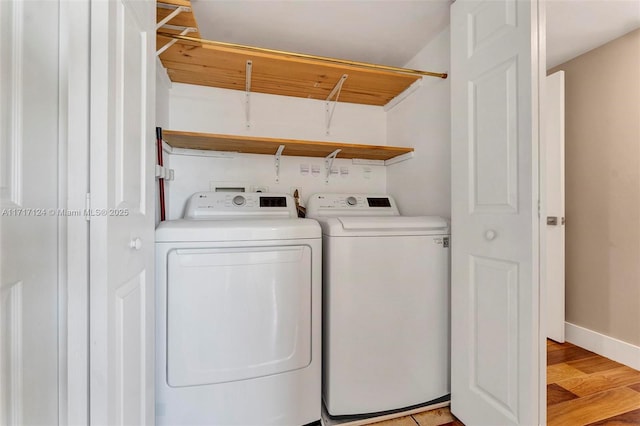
[164,84,387,219]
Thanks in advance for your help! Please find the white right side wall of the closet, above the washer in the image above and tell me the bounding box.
[387,28,451,218]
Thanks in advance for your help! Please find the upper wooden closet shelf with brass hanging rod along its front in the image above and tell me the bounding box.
[157,0,446,106]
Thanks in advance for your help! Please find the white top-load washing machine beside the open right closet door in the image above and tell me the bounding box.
[307,194,450,416]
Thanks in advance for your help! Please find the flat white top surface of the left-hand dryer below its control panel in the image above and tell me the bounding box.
[156,218,322,243]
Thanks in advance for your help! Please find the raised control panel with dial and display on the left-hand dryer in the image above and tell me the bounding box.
[184,192,298,220]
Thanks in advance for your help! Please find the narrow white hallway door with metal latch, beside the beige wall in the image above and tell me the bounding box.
[540,71,565,343]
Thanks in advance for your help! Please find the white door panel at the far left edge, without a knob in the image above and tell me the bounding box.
[0,0,60,426]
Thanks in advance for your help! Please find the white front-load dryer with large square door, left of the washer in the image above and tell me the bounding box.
[156,192,322,426]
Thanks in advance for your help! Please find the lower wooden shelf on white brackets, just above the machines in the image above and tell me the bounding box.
[162,130,413,160]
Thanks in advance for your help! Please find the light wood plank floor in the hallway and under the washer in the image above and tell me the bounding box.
[368,340,640,426]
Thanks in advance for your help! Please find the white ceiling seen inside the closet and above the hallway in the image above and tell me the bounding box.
[192,0,640,71]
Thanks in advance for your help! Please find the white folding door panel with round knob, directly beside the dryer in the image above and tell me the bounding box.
[90,0,155,425]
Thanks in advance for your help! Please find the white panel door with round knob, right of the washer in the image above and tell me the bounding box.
[451,0,544,426]
